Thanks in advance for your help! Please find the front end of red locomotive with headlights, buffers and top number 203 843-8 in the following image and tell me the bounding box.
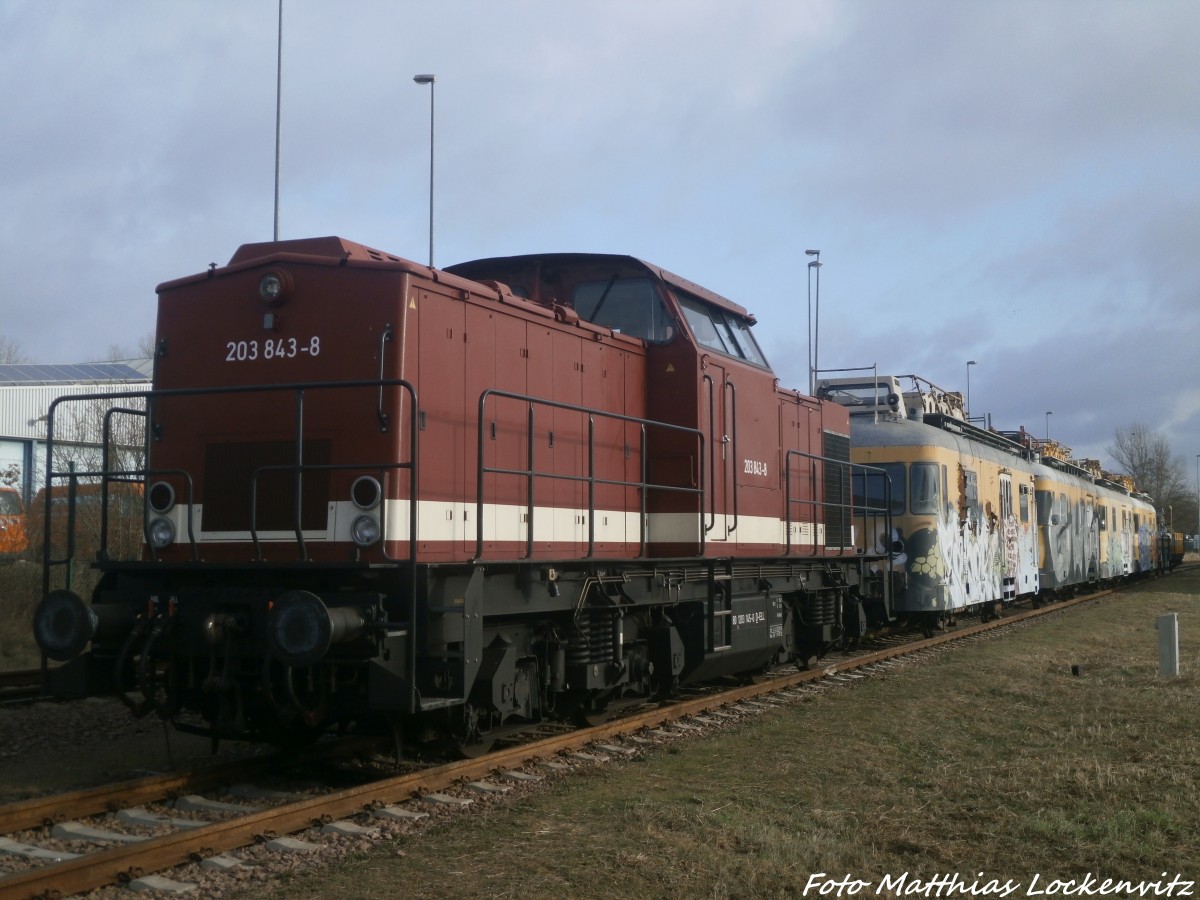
[35,238,428,739]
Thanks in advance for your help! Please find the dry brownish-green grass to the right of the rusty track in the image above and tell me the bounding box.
[246,572,1200,900]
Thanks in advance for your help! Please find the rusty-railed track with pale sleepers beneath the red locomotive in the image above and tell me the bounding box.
[0,590,1112,898]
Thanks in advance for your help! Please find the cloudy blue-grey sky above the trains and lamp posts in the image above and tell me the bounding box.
[0,0,1200,474]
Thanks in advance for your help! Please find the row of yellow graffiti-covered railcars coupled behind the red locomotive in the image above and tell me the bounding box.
[818,376,1156,623]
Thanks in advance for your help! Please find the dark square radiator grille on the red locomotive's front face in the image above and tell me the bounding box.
[202,440,330,532]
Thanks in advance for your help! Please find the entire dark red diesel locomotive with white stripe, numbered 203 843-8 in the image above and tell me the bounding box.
[35,238,890,748]
